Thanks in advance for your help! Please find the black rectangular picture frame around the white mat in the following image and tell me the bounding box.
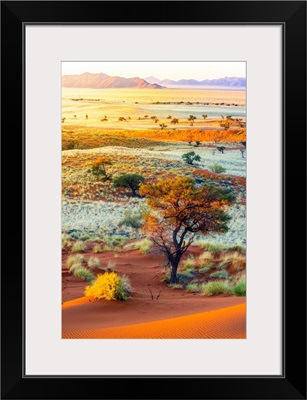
[1,1,306,399]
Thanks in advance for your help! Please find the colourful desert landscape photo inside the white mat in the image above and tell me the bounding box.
[61,62,247,339]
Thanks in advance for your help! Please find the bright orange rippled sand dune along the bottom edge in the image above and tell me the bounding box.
[62,303,246,339]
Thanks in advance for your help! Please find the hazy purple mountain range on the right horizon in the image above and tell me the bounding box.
[145,76,246,87]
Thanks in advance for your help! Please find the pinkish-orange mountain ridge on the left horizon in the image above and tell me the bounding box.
[62,72,163,89]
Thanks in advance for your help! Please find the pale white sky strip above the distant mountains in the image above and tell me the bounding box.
[62,61,246,81]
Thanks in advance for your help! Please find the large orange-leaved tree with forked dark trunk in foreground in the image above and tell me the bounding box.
[140,177,235,284]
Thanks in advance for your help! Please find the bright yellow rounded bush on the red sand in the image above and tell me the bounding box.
[84,272,131,301]
